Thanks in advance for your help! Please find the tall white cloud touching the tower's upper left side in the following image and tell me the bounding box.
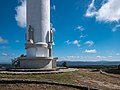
[15,0,26,28]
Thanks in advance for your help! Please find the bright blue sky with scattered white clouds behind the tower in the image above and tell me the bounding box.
[0,0,120,63]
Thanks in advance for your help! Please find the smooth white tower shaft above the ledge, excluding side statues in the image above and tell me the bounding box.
[27,0,50,43]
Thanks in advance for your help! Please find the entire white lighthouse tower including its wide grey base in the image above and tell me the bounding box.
[18,0,55,69]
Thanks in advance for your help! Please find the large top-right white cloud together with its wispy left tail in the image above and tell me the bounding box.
[86,0,120,22]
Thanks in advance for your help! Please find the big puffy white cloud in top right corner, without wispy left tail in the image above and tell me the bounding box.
[96,0,120,22]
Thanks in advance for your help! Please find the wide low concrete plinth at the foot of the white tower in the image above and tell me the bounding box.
[18,57,54,69]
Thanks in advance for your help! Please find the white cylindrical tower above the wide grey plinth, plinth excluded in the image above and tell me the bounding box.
[26,0,50,57]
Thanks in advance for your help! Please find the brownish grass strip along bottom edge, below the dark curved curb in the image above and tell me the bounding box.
[0,84,80,90]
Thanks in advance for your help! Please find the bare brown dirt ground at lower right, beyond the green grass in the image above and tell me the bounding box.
[78,69,120,90]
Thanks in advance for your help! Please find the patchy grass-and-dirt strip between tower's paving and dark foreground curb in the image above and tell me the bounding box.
[0,69,120,90]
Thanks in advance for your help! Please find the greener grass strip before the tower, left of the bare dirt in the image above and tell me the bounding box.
[0,71,87,84]
